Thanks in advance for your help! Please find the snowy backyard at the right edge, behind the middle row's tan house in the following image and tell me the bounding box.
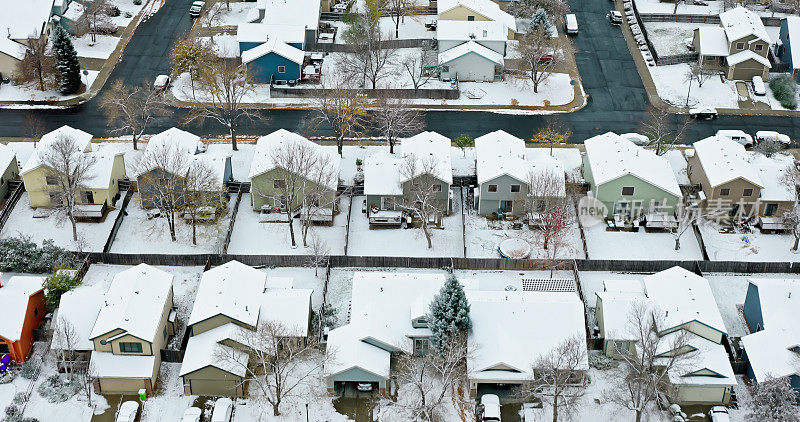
[700,224,800,262]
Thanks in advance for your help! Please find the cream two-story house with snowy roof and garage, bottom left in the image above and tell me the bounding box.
[89,264,176,394]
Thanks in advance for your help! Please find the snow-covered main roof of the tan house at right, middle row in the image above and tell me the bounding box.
[692,136,764,187]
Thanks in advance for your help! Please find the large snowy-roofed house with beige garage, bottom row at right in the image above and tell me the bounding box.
[596,267,736,405]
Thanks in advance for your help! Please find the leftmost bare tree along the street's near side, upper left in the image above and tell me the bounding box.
[100,79,170,149]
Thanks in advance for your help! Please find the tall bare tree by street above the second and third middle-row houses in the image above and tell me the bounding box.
[186,59,261,151]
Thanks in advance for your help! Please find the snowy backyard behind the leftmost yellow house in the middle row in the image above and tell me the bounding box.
[0,192,121,252]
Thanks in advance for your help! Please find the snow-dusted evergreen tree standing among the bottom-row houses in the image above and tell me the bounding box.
[428,275,472,349]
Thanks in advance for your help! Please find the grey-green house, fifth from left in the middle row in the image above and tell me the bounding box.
[475,130,566,218]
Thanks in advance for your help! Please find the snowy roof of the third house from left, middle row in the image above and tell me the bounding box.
[248,129,341,189]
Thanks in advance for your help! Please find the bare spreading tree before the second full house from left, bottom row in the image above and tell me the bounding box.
[214,322,326,416]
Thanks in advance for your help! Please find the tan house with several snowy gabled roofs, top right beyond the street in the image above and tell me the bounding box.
[692,6,772,80]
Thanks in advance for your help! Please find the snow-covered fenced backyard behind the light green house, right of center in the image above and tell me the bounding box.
[583,224,708,261]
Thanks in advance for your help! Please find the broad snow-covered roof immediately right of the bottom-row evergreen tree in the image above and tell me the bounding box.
[466,290,589,379]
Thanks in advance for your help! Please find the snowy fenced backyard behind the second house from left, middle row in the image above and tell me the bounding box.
[111,193,233,254]
